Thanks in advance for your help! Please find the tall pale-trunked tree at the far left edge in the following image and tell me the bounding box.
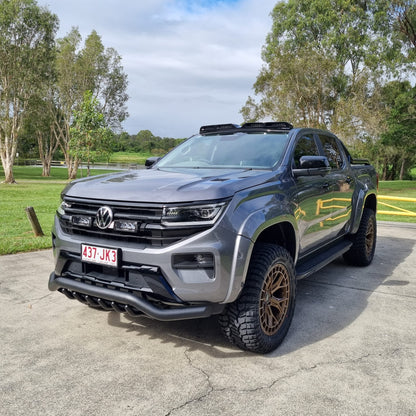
[0,0,58,183]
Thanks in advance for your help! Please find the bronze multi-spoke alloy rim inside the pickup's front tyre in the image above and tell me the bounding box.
[259,263,290,335]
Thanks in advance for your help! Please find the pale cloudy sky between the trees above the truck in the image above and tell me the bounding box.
[38,0,277,138]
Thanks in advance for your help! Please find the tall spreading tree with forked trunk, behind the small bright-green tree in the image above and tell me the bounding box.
[55,29,128,179]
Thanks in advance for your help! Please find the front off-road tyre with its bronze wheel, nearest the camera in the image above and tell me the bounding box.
[219,244,296,354]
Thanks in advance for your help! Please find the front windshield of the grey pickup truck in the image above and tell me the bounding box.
[157,133,288,169]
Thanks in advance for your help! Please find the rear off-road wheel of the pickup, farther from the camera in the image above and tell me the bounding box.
[344,208,377,267]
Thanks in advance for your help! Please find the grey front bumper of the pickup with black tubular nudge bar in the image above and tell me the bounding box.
[49,214,251,308]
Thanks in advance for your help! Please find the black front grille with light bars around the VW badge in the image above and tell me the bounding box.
[57,198,209,247]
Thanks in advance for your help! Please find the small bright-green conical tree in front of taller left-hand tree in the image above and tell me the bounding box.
[70,91,112,176]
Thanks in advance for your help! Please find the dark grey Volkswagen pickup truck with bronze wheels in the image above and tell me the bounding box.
[49,122,377,353]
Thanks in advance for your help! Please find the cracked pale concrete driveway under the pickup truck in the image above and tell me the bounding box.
[0,224,416,416]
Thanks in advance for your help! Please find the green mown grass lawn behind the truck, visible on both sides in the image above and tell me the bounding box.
[0,166,416,254]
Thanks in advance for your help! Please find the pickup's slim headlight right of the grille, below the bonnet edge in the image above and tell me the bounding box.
[162,202,226,226]
